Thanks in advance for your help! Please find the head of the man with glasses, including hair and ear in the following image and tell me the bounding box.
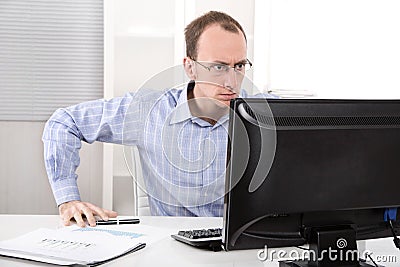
[183,11,250,107]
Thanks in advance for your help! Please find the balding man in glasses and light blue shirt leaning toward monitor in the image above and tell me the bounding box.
[43,11,276,227]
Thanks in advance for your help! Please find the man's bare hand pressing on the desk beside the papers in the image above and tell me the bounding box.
[58,200,118,227]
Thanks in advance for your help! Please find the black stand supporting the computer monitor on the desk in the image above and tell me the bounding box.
[279,225,382,267]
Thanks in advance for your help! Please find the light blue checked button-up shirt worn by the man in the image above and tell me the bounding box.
[42,84,272,216]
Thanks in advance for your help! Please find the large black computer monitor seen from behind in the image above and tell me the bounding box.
[223,98,400,266]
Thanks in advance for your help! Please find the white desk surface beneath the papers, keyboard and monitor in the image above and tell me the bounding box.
[0,215,400,267]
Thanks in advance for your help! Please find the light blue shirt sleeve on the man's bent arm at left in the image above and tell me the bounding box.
[42,93,140,205]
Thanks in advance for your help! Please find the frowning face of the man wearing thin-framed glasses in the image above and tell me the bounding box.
[192,25,247,106]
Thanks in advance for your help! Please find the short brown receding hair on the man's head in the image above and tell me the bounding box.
[185,11,247,60]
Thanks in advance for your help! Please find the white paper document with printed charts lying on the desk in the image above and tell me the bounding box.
[0,225,167,265]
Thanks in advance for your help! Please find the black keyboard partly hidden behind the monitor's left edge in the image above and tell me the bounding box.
[171,228,222,251]
